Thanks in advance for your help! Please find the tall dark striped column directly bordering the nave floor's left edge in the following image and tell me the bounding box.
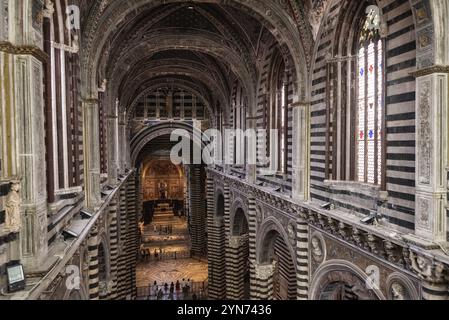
[126,175,139,299]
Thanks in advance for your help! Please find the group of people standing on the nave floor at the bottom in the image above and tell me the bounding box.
[149,279,198,300]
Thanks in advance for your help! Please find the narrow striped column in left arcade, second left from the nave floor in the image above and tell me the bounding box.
[109,197,119,300]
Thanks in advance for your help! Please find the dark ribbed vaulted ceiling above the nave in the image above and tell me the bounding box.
[82,0,310,119]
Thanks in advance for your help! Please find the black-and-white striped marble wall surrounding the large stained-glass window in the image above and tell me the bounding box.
[310,0,416,232]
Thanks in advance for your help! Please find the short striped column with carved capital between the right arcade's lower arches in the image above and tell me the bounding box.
[251,262,276,300]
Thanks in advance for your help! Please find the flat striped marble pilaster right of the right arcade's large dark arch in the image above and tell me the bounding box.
[296,217,309,300]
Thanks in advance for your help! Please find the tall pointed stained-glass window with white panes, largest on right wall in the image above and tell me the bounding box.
[356,9,384,185]
